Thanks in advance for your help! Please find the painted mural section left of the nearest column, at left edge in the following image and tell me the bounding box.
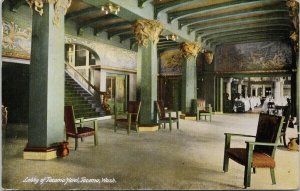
[2,20,31,59]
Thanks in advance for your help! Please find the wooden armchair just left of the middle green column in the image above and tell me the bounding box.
[115,101,141,135]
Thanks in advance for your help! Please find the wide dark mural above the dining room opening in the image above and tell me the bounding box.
[215,41,292,72]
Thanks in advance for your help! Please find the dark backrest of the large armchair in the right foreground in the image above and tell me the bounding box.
[254,113,284,156]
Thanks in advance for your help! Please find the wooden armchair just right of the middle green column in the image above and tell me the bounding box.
[154,100,179,131]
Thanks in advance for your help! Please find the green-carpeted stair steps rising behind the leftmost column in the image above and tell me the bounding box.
[65,72,106,118]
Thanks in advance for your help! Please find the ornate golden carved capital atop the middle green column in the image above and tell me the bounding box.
[133,19,163,47]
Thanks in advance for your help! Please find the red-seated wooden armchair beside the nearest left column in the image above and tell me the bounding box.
[64,105,98,150]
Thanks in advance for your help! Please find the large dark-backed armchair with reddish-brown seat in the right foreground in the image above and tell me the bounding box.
[223,113,284,188]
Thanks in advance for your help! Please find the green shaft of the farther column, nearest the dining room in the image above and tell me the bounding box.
[181,57,197,114]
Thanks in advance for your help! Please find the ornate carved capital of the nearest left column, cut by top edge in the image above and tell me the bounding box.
[26,0,72,26]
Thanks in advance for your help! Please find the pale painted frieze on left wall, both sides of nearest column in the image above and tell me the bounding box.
[2,19,137,70]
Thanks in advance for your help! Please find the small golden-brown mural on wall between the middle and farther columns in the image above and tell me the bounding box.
[160,50,183,74]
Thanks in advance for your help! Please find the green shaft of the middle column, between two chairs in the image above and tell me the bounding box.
[137,41,157,124]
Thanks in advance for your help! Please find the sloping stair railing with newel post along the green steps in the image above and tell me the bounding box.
[65,63,111,114]
